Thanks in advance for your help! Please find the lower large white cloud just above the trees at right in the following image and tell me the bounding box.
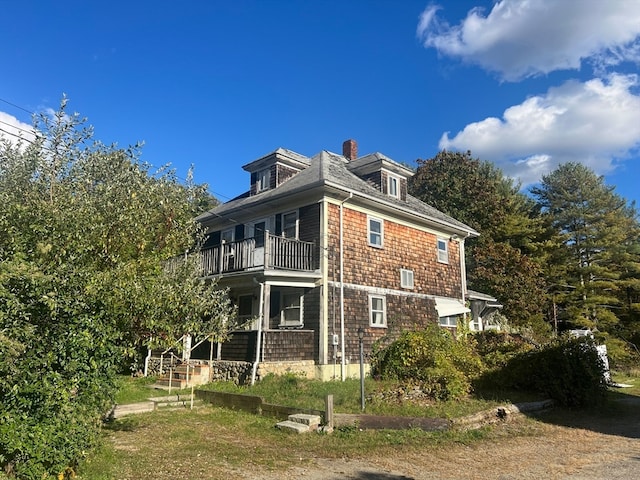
[440,74,640,185]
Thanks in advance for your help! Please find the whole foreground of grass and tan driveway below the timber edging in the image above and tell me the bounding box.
[79,376,640,480]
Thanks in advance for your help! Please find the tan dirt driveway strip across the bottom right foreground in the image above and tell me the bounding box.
[246,395,640,480]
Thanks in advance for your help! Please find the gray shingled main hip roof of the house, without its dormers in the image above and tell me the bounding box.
[196,150,478,236]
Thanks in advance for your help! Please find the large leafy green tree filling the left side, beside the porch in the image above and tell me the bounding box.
[0,99,234,479]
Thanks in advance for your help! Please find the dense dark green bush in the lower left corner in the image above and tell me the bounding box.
[0,261,119,480]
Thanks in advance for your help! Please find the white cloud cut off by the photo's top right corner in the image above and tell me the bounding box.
[417,0,640,81]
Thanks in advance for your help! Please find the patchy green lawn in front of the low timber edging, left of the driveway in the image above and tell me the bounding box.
[78,407,502,480]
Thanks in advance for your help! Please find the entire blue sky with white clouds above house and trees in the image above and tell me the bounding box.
[0,0,640,208]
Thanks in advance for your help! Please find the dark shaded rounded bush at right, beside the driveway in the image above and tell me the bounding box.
[477,337,607,407]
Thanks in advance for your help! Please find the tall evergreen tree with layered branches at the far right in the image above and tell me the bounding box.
[531,163,640,332]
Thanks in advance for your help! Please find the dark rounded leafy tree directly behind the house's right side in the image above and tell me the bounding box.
[409,151,546,333]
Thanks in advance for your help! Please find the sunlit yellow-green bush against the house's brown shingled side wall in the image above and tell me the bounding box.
[371,325,482,400]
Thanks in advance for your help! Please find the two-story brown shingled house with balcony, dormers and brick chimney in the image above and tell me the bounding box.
[197,140,478,379]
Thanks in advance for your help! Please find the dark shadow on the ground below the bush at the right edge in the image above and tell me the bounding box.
[532,391,640,438]
